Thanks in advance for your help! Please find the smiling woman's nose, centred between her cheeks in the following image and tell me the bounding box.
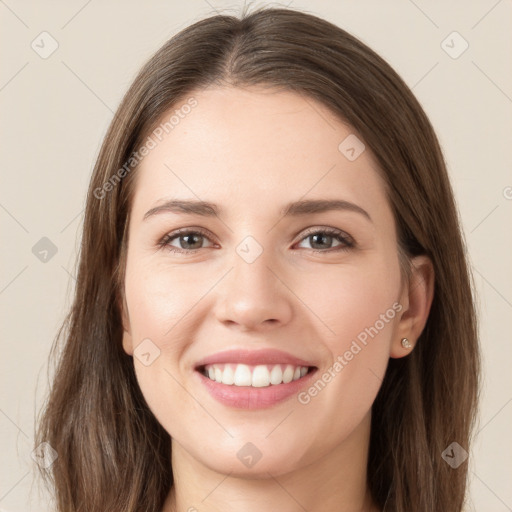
[212,251,294,331]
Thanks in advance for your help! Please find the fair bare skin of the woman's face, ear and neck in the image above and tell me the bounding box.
[122,86,433,512]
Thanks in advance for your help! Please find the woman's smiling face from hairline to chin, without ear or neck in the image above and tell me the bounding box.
[123,87,410,477]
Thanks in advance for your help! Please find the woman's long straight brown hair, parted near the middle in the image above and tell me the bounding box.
[35,8,480,512]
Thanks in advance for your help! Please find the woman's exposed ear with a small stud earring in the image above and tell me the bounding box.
[390,256,435,358]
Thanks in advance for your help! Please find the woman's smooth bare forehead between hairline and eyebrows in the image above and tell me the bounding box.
[133,87,389,223]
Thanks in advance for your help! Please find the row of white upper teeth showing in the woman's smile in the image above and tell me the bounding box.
[203,364,308,388]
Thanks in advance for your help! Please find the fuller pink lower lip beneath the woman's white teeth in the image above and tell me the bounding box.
[194,368,317,409]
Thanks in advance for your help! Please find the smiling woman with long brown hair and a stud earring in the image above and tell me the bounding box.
[37,8,479,512]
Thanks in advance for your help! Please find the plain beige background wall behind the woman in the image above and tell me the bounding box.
[0,0,512,512]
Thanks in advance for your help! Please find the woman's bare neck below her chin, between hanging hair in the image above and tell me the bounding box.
[162,414,378,512]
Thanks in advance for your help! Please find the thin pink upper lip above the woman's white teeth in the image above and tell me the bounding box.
[195,349,314,369]
